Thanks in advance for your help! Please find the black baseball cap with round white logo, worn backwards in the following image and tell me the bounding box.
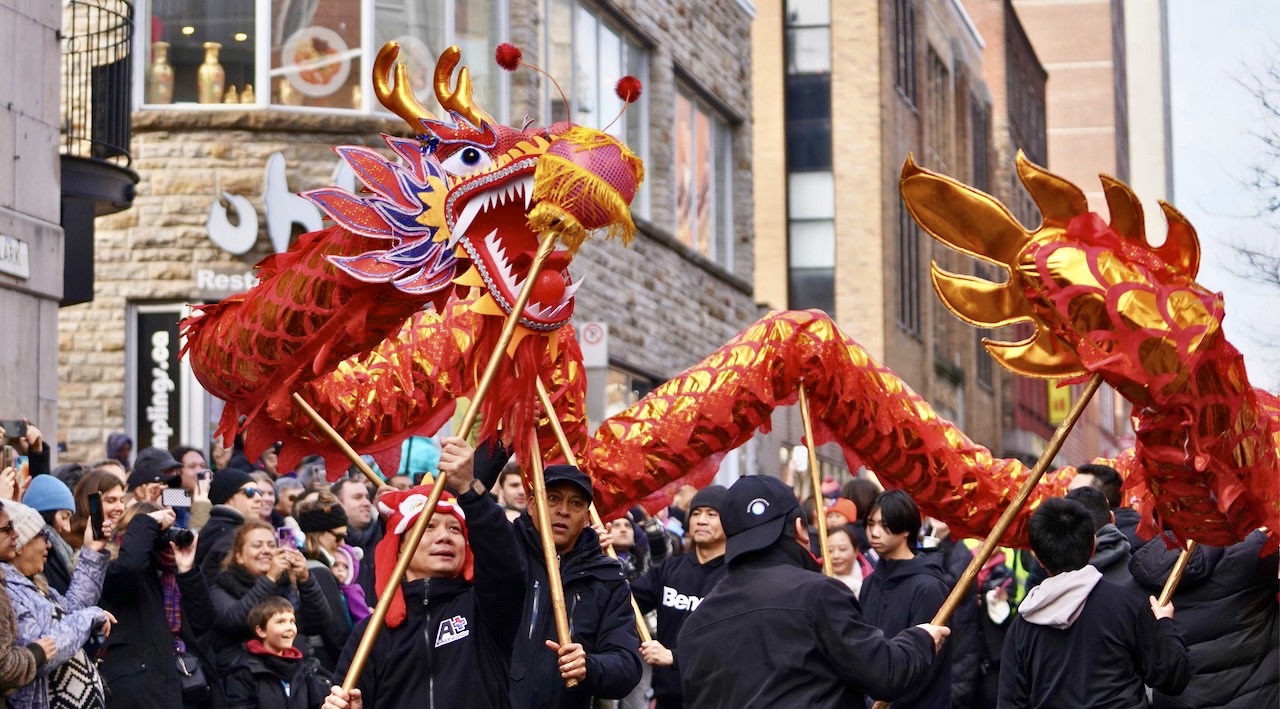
[719,475,800,562]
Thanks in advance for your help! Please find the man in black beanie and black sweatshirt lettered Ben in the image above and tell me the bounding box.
[631,485,727,709]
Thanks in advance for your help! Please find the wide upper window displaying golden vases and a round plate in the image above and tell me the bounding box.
[137,0,506,115]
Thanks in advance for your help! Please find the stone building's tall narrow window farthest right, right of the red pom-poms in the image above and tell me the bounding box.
[675,84,733,269]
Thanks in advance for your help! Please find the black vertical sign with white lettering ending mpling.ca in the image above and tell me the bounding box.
[134,308,182,450]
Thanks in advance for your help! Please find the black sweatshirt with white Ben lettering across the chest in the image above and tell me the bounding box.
[631,552,727,709]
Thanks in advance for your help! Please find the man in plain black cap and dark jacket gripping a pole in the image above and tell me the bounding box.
[511,465,643,709]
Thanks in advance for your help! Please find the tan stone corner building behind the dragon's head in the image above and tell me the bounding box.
[58,0,756,473]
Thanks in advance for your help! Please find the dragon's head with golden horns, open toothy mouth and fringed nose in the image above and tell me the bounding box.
[306,42,644,334]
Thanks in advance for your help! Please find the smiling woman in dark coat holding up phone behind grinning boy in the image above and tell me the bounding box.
[207,520,333,669]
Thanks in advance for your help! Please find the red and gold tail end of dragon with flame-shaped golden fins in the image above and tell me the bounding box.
[901,152,1222,403]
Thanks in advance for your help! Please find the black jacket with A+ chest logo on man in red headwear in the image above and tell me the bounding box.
[334,491,526,709]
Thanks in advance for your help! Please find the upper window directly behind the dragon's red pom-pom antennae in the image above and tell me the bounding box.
[542,0,649,216]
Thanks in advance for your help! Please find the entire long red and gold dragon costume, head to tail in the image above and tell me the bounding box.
[184,45,1280,545]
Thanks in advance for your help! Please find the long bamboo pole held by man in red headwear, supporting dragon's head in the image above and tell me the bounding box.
[334,232,568,691]
